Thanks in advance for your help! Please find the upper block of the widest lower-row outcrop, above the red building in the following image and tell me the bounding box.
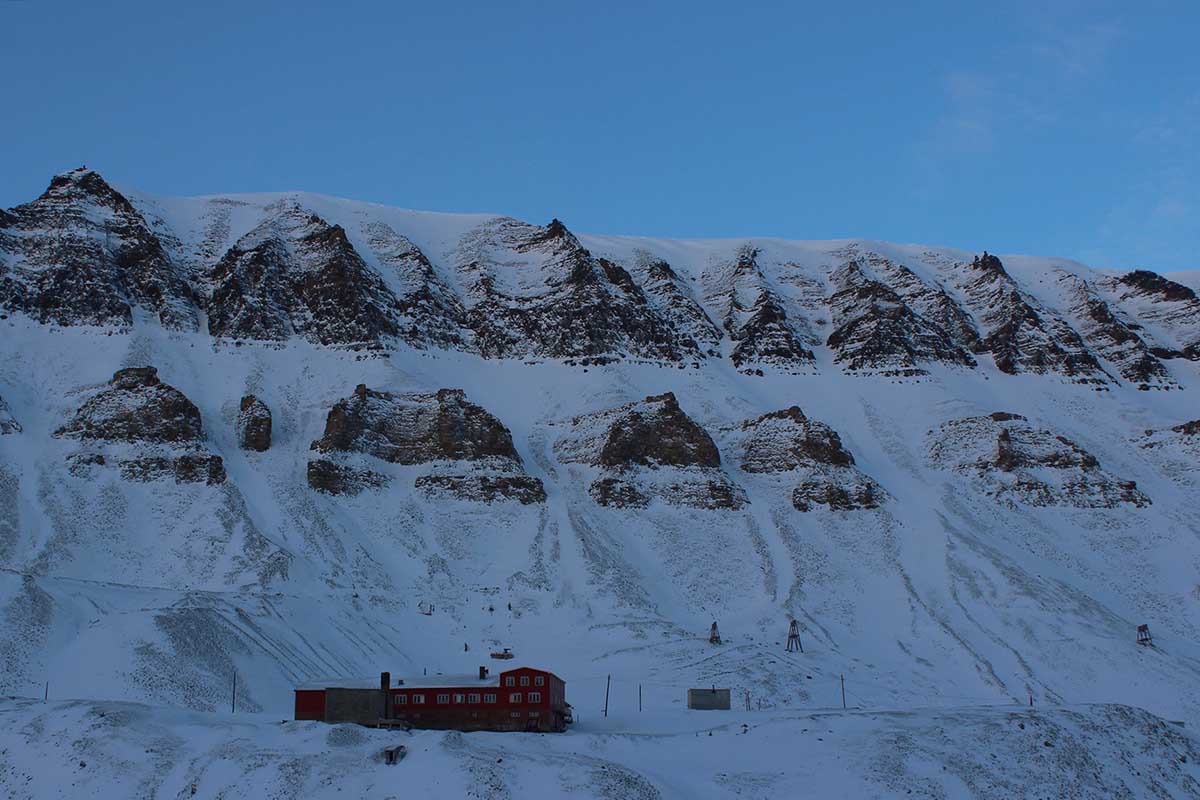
[312,384,521,467]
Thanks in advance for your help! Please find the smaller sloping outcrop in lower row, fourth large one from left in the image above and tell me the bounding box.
[725,405,887,511]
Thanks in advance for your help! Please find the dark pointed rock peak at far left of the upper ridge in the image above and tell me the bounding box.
[0,168,197,330]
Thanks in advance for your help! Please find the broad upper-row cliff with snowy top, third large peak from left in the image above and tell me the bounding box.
[457,218,698,361]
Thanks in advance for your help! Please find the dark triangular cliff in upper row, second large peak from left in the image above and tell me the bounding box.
[209,204,400,344]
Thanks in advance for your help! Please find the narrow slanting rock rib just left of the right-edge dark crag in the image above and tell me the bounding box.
[1055,270,1177,390]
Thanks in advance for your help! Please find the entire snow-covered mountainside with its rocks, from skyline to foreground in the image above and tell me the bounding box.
[0,168,1200,799]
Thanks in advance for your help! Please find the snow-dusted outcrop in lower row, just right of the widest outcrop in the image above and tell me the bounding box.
[554,392,749,509]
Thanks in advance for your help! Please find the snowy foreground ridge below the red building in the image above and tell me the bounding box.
[0,700,1200,800]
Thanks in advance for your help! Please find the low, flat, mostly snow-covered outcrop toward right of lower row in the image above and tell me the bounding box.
[929,413,1151,509]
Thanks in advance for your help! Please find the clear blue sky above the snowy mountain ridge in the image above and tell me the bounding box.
[0,0,1200,270]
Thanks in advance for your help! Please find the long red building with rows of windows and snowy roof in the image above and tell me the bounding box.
[295,667,571,732]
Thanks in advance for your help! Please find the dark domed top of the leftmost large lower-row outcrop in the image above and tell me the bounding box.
[54,367,203,445]
